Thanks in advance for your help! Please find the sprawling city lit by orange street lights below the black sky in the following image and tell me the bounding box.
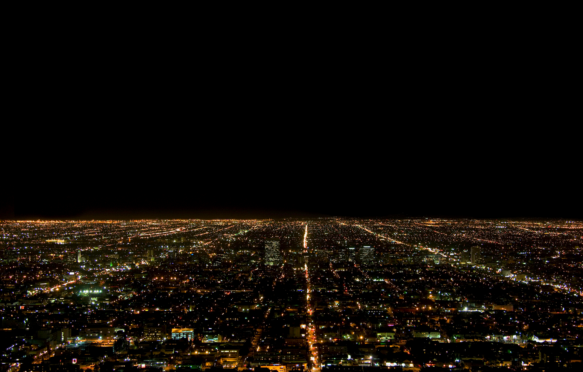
[0,218,583,372]
